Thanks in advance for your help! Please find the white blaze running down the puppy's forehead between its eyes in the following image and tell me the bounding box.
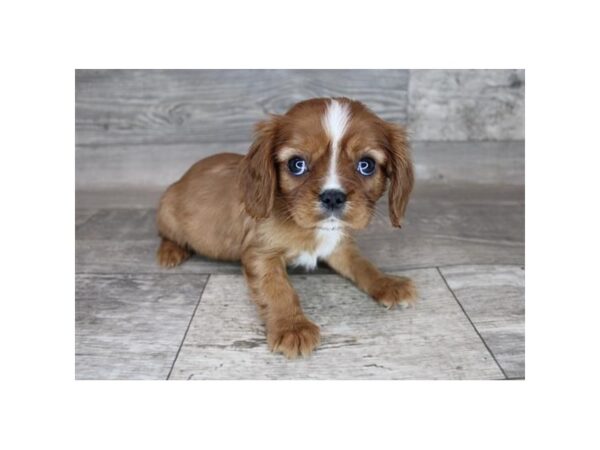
[322,100,350,191]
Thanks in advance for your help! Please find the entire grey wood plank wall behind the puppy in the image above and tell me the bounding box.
[75,70,525,191]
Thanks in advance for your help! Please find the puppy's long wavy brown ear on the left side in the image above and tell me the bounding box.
[239,116,279,219]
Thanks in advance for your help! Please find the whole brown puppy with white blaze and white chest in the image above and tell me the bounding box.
[157,98,416,358]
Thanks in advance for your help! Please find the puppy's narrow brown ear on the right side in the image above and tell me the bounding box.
[385,123,414,227]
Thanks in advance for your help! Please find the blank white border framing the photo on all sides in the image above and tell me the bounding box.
[0,0,600,449]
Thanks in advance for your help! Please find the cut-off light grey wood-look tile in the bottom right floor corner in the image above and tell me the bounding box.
[441,266,525,378]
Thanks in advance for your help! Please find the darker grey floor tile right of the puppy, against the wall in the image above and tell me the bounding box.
[357,185,525,270]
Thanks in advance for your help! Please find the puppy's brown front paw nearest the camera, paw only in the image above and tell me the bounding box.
[267,317,320,358]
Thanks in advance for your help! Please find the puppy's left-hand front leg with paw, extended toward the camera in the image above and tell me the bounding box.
[242,250,319,358]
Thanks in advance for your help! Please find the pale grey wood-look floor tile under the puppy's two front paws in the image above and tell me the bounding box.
[171,269,503,379]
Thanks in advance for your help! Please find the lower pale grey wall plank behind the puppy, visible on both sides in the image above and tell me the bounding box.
[75,141,525,191]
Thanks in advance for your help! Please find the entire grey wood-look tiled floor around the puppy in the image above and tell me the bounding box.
[75,184,525,379]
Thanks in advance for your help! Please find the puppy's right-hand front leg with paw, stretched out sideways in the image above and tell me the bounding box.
[326,241,417,308]
